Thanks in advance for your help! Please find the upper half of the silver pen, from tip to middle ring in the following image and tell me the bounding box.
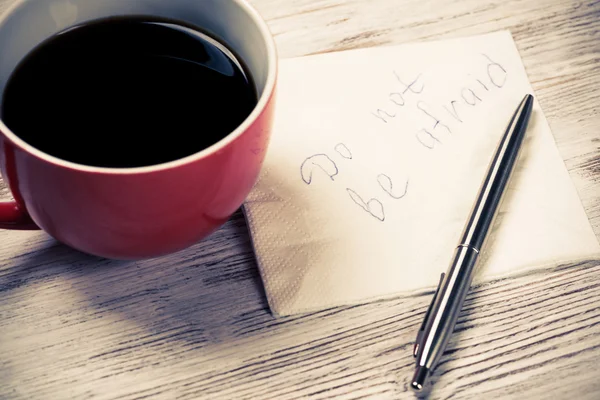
[460,96,533,251]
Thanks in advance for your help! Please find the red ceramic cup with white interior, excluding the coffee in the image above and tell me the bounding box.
[0,0,277,259]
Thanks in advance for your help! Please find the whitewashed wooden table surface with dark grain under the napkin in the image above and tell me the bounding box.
[0,0,600,399]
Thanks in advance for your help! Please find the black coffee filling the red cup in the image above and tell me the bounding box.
[1,18,257,168]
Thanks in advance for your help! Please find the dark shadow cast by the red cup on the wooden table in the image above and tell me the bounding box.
[0,212,272,344]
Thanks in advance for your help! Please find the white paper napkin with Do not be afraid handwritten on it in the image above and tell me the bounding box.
[244,32,600,315]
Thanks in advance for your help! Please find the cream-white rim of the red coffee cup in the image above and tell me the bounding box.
[0,0,278,175]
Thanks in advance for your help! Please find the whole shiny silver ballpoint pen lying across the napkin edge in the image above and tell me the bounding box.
[411,94,533,391]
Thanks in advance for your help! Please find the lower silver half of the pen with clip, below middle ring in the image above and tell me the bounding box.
[417,246,479,370]
